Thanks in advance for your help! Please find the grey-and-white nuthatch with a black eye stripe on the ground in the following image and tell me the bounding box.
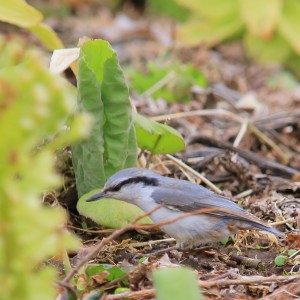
[86,168,284,249]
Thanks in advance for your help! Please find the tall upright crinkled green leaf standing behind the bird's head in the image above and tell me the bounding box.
[72,40,137,196]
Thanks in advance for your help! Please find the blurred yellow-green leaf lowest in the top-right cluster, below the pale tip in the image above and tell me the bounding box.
[244,34,291,63]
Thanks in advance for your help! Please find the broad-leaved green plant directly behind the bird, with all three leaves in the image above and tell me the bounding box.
[72,40,184,228]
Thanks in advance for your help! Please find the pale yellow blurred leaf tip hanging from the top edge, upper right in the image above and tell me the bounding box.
[239,0,282,39]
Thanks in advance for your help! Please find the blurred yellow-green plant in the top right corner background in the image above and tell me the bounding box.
[176,0,300,63]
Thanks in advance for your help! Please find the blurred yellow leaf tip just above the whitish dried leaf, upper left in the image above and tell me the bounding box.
[28,23,64,50]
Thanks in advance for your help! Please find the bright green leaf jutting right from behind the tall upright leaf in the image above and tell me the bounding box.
[133,114,185,154]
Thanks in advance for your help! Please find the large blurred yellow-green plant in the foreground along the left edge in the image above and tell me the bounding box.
[0,40,90,300]
